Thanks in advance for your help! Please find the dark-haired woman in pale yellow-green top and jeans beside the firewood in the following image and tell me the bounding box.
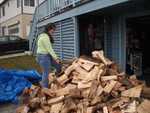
[37,24,61,87]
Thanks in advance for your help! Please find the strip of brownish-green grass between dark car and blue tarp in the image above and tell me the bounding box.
[0,55,41,72]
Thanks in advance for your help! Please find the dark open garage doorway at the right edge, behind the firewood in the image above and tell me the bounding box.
[126,15,150,80]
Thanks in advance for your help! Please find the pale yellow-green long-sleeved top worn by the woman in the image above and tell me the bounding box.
[37,33,58,60]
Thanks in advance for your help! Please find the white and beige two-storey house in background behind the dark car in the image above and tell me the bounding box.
[0,0,38,38]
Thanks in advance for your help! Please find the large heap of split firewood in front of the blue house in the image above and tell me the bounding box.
[16,51,150,113]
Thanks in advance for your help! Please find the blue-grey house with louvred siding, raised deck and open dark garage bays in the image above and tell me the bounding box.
[29,0,150,76]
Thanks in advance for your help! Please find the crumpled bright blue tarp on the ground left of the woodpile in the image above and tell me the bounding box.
[0,69,41,103]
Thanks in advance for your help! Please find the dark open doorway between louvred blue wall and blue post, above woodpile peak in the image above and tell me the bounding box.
[78,12,104,56]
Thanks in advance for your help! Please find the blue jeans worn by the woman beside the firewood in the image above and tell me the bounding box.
[36,54,61,87]
